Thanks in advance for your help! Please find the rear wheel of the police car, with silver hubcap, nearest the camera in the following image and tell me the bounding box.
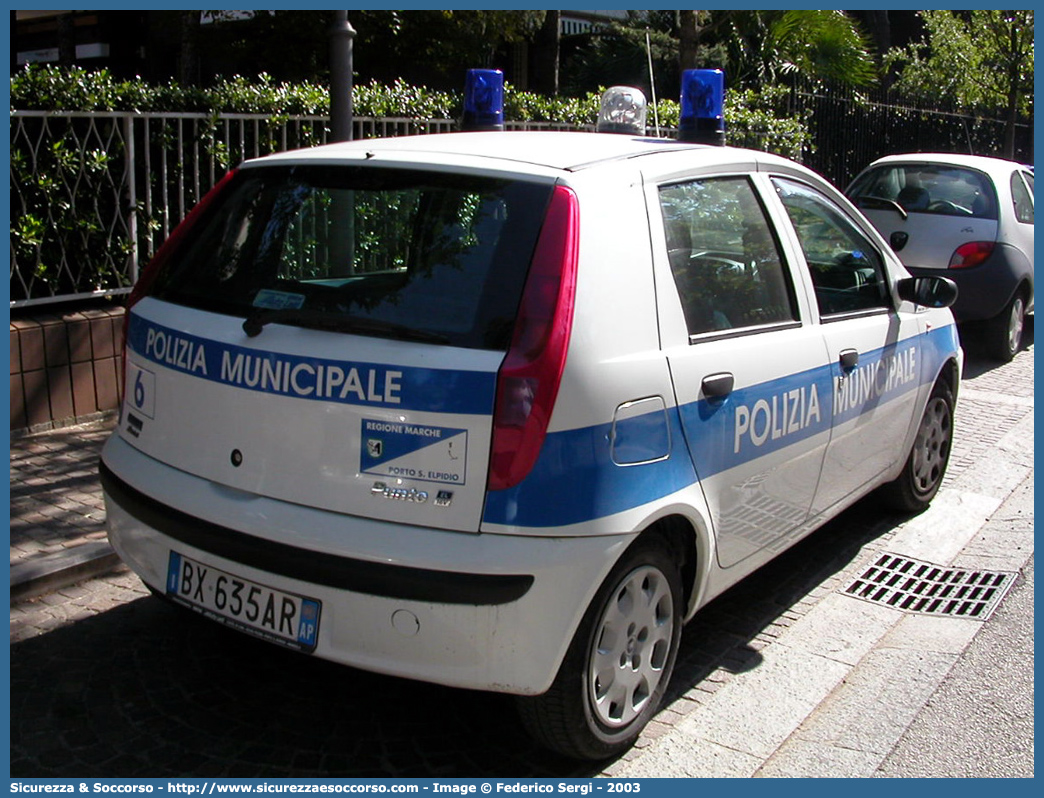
[517,535,685,760]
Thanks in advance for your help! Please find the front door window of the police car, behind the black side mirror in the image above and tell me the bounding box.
[773,178,892,316]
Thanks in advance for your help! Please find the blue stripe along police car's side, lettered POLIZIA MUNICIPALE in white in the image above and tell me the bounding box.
[482,326,957,529]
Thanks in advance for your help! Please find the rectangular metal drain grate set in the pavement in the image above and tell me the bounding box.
[845,554,1016,620]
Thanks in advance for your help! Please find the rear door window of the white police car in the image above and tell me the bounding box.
[660,178,798,335]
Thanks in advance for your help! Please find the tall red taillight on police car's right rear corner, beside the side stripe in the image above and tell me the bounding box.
[488,186,579,491]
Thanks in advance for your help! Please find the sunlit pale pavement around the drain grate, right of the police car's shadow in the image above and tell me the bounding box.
[607,436,1034,778]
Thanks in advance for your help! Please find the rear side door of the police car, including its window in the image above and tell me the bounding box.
[653,174,831,567]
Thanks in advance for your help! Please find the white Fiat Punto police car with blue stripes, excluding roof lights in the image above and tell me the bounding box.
[101,127,962,758]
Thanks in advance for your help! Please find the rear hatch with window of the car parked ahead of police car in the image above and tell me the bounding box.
[847,162,998,268]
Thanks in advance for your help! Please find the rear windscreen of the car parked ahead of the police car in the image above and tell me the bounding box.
[848,164,997,219]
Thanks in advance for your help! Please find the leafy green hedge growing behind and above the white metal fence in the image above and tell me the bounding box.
[10,65,809,300]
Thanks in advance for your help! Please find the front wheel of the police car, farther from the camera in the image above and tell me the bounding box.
[881,379,954,513]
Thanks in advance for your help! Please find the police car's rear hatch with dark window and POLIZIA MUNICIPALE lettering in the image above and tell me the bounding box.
[120,158,552,532]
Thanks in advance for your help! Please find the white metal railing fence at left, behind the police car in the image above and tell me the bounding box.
[10,111,463,307]
